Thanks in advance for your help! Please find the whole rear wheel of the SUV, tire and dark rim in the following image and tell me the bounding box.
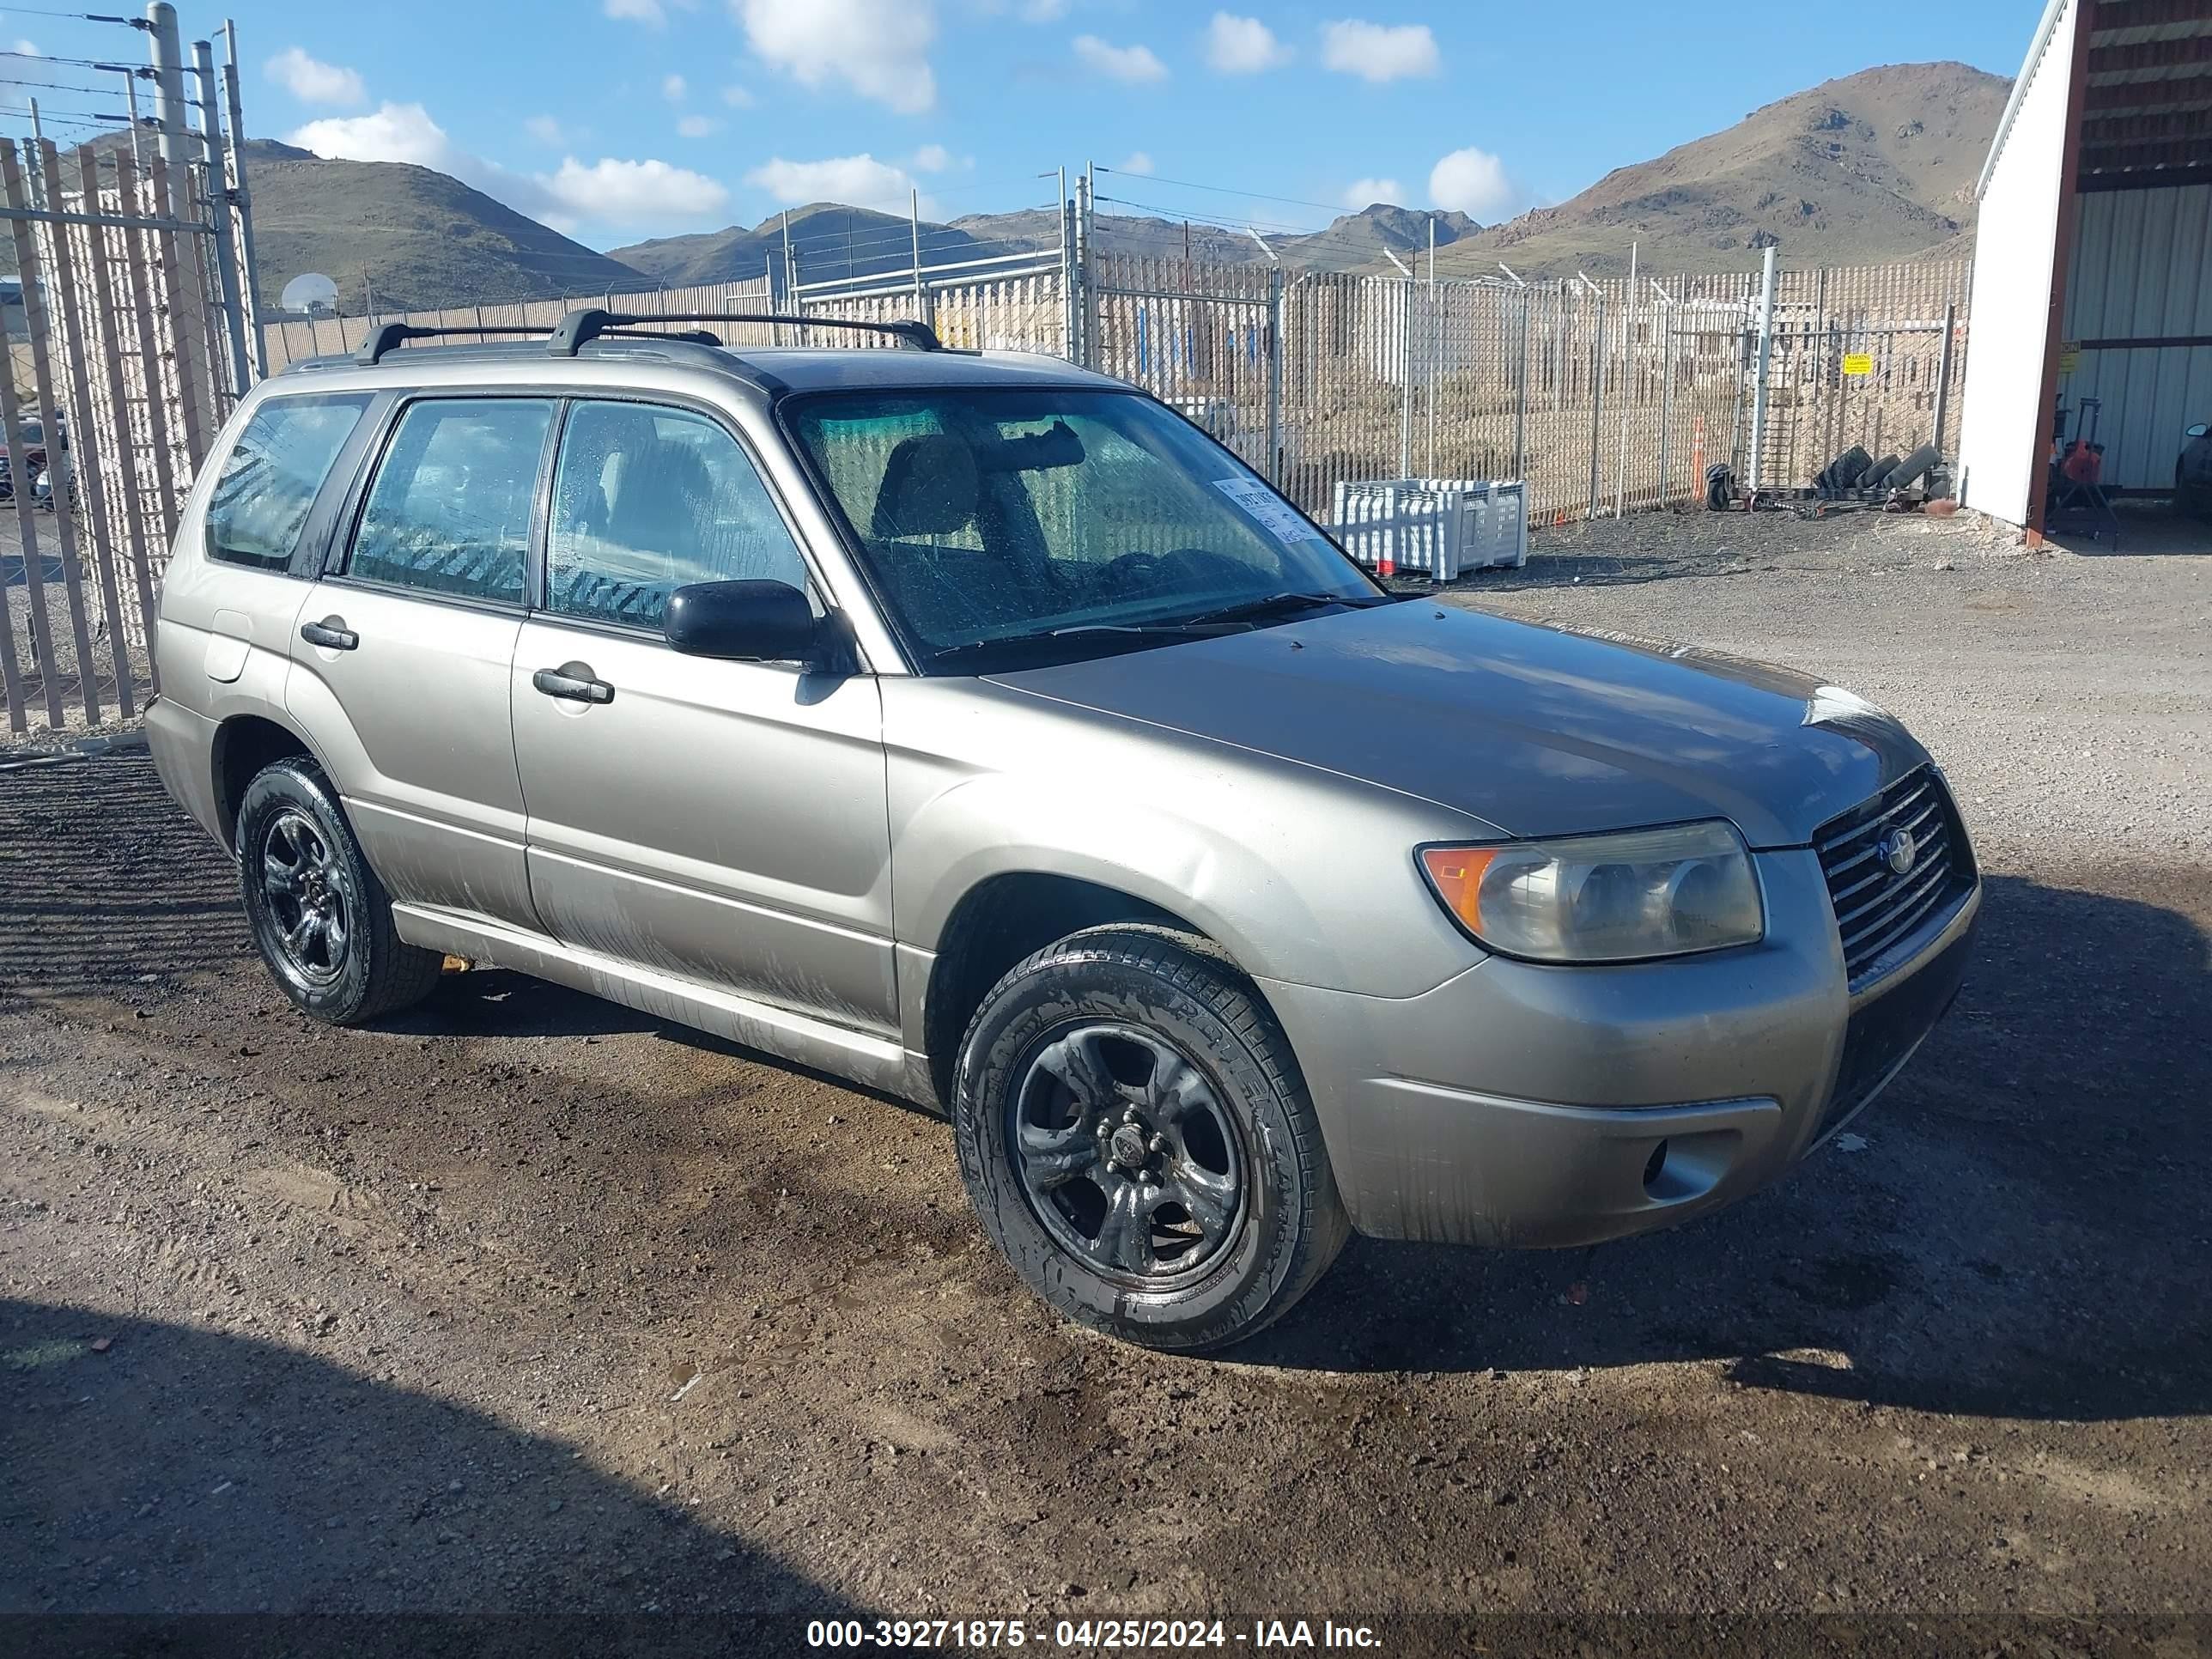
[237,757,445,1026]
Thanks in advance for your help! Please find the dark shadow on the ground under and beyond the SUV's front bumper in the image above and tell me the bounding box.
[1234,869,2212,1418]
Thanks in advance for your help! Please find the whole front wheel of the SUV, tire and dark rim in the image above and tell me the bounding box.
[953,925,1349,1352]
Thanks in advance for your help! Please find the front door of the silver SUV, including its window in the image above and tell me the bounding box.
[514,398,898,1033]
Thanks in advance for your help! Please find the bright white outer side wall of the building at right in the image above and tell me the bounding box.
[1958,0,2081,525]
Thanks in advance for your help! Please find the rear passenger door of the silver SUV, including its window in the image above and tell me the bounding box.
[285,396,557,929]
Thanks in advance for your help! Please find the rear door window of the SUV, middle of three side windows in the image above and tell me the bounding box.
[345,398,553,604]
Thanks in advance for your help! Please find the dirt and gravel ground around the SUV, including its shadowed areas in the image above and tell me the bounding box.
[0,515,2212,1655]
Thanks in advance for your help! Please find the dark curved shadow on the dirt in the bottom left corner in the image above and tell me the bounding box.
[0,1298,860,1652]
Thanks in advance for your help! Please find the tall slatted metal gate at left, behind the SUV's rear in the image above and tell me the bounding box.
[0,139,234,732]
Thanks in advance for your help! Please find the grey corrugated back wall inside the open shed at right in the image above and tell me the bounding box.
[2059,184,2212,489]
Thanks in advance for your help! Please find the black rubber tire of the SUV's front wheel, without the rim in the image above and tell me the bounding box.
[953,922,1352,1354]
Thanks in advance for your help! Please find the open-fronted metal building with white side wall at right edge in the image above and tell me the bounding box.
[1960,0,2212,535]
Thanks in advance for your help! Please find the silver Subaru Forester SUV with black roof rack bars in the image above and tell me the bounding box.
[149,312,1980,1352]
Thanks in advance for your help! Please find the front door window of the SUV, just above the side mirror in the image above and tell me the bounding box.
[546,403,807,629]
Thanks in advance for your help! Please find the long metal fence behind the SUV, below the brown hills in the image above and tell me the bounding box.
[265,228,1966,539]
